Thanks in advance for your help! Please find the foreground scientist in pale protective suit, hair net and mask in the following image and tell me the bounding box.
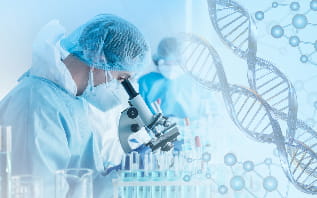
[0,14,150,198]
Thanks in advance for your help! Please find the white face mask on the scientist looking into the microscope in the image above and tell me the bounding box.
[82,70,121,112]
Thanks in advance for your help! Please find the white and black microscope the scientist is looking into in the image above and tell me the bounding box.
[118,79,180,153]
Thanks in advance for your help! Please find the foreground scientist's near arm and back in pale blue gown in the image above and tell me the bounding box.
[0,85,70,198]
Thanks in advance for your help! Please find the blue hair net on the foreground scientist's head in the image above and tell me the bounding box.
[61,14,150,72]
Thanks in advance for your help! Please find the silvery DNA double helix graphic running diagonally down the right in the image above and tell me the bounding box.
[180,0,317,194]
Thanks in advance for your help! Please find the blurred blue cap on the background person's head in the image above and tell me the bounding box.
[153,37,182,65]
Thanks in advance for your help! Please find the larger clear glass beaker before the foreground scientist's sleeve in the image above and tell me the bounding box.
[55,168,93,198]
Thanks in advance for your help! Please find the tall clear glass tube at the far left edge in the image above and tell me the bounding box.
[0,126,11,198]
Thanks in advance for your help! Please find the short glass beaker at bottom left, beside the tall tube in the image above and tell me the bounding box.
[11,175,43,198]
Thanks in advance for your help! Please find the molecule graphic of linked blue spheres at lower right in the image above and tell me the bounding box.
[183,152,289,198]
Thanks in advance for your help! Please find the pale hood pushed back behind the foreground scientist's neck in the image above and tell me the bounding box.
[28,20,77,96]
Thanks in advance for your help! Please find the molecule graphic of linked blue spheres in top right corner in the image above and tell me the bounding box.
[254,0,317,66]
